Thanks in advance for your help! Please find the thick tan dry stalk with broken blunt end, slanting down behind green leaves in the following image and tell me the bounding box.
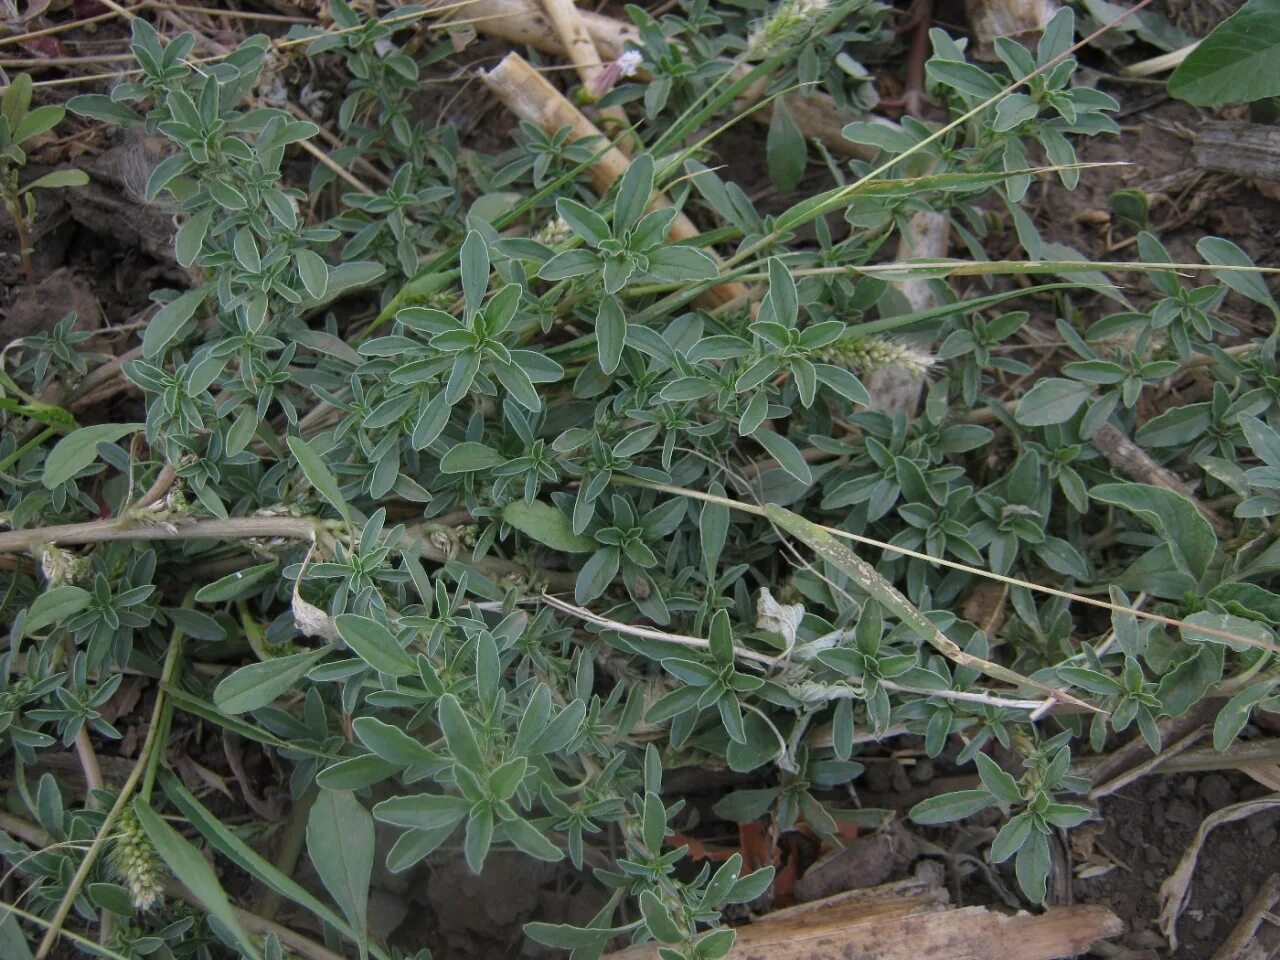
[480,51,748,308]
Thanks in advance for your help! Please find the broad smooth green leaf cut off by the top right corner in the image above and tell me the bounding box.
[1169,0,1280,106]
